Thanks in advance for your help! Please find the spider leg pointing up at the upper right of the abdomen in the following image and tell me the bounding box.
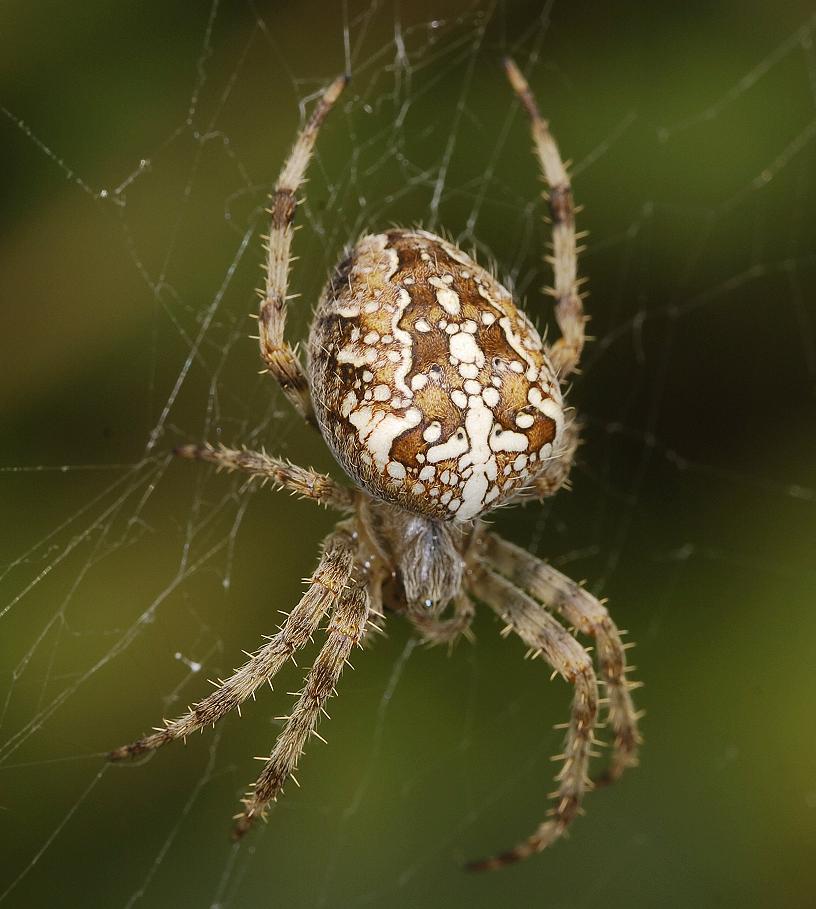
[504,58,587,380]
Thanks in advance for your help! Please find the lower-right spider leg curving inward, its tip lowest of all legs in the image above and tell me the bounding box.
[467,567,598,871]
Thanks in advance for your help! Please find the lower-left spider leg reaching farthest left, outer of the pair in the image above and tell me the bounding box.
[108,532,355,761]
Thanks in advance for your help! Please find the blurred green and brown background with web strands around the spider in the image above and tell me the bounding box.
[0,0,816,909]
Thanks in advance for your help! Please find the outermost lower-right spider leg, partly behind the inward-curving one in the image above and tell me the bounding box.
[484,534,641,783]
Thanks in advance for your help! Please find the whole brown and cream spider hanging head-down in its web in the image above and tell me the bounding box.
[109,59,640,869]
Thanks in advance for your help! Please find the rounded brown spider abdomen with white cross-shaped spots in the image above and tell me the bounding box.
[309,229,564,521]
